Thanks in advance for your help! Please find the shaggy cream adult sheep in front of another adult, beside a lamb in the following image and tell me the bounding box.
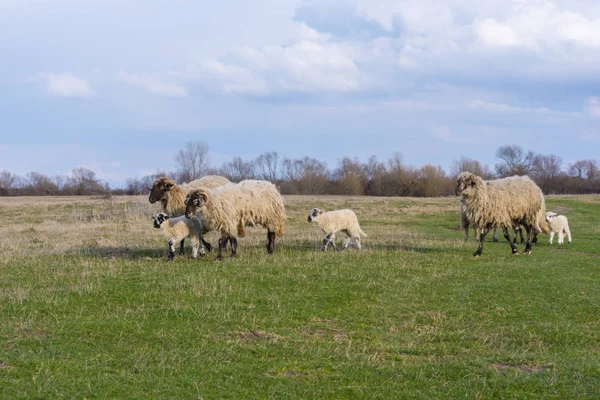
[185,180,287,261]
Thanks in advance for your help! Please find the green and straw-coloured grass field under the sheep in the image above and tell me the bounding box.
[0,196,600,399]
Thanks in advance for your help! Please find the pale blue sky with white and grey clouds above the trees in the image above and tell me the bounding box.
[0,0,600,186]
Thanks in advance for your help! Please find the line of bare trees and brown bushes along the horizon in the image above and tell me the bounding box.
[0,142,600,197]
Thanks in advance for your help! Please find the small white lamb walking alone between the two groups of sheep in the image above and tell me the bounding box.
[308,208,367,251]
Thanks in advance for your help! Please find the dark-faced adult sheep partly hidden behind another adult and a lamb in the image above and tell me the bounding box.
[148,175,231,254]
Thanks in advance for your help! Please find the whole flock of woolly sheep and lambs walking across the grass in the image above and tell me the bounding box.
[148,172,571,260]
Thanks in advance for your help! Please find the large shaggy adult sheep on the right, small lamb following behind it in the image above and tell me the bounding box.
[456,172,548,257]
